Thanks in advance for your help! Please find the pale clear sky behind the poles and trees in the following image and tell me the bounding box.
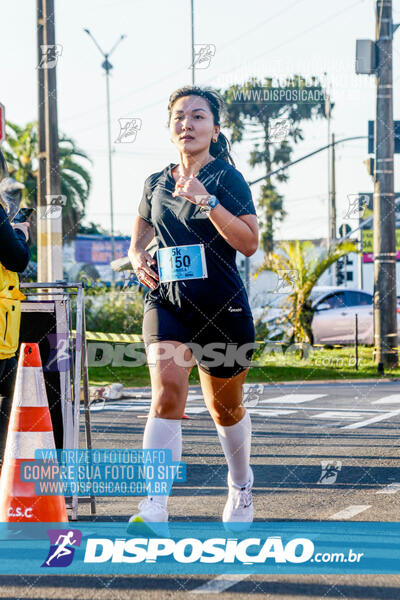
[0,0,400,238]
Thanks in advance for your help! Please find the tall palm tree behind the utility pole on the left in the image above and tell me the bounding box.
[3,121,91,239]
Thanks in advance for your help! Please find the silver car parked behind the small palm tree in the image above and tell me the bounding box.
[253,286,400,344]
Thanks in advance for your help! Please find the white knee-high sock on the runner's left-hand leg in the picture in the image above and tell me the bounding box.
[143,417,182,508]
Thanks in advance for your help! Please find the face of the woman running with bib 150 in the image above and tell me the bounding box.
[169,95,220,154]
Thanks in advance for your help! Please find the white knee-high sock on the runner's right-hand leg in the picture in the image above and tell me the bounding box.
[215,410,251,487]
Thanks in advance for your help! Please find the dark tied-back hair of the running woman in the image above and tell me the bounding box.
[168,85,235,166]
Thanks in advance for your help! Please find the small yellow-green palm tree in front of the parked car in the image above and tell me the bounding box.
[256,240,357,344]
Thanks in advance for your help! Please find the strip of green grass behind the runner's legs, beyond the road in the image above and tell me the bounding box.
[89,346,400,387]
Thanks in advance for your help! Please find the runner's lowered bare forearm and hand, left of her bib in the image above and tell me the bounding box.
[128,216,158,290]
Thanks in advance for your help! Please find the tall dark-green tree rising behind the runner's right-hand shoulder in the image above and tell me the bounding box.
[224,75,333,252]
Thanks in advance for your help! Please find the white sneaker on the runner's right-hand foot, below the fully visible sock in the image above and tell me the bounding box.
[222,468,254,531]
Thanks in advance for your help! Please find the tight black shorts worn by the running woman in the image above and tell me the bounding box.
[143,304,255,378]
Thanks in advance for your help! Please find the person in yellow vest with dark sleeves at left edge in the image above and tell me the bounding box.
[0,152,30,468]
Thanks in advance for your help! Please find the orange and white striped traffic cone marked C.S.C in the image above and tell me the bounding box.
[0,344,68,523]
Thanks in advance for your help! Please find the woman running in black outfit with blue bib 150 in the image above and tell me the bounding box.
[129,86,258,527]
